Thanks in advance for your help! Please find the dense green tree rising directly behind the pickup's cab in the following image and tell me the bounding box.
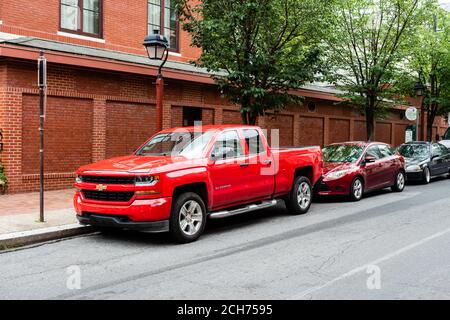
[176,0,330,124]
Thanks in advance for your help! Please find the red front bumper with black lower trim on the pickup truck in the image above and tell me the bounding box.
[73,192,172,231]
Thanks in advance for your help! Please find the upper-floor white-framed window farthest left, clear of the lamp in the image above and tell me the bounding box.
[60,0,102,37]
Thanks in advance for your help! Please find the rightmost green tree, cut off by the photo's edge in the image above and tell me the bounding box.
[398,2,450,141]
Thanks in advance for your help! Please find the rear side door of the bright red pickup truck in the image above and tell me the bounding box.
[242,129,275,201]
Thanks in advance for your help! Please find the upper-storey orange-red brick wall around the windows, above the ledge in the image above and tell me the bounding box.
[0,0,200,61]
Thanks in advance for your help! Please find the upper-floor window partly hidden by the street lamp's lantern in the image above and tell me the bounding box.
[147,0,178,51]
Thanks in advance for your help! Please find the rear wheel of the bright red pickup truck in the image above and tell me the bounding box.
[285,176,312,215]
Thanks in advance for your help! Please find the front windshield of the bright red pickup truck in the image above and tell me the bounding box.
[136,131,214,159]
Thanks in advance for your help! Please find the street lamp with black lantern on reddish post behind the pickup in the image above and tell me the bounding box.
[144,32,169,131]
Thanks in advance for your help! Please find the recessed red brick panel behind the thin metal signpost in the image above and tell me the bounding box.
[22,94,93,174]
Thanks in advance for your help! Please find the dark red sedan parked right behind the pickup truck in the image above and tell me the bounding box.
[317,142,405,201]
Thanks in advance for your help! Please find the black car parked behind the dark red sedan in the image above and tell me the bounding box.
[398,141,450,183]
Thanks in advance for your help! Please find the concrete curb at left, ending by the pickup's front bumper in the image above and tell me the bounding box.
[0,223,95,250]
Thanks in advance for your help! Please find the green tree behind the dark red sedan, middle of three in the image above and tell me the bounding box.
[324,0,429,140]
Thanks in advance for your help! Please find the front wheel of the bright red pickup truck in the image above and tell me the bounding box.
[170,192,206,243]
